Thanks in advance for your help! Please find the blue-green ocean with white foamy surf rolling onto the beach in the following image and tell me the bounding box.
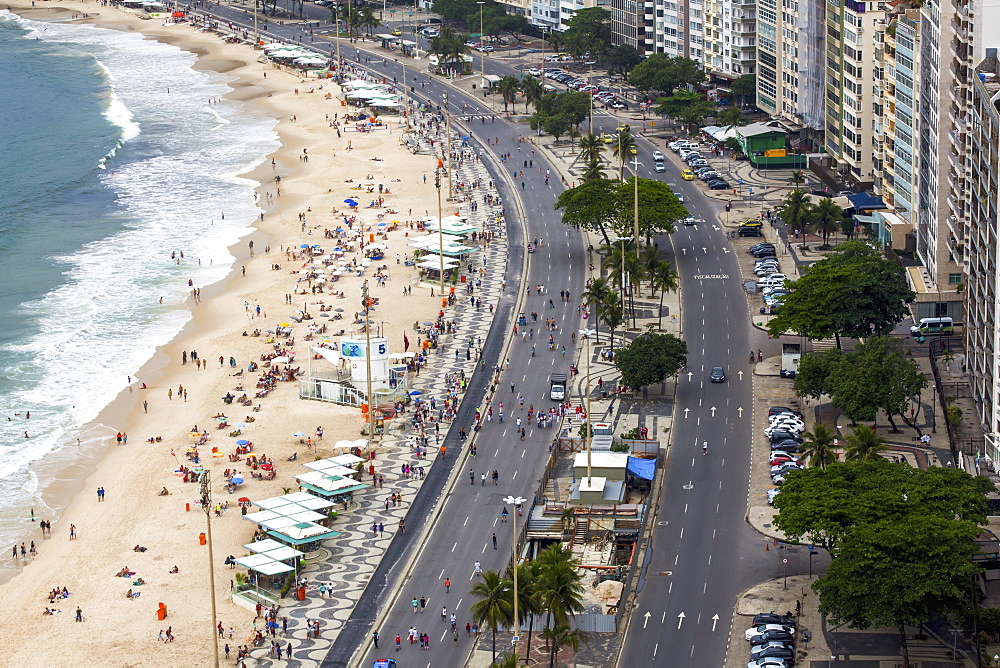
[0,12,278,545]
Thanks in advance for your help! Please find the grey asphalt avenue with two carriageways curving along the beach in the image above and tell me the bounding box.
[178,7,777,667]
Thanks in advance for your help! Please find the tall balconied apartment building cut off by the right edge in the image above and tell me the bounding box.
[962,48,1000,462]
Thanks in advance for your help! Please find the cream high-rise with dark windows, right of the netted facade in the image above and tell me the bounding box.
[825,0,886,185]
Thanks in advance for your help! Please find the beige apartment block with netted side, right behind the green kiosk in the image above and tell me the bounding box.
[756,0,827,144]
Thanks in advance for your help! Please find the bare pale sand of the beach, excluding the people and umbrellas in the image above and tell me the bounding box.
[0,0,464,666]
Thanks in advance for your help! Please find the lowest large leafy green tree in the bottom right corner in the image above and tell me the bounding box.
[812,512,981,665]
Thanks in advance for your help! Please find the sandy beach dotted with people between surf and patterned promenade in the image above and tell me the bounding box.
[0,1,496,666]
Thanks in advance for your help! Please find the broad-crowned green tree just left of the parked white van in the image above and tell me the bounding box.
[767,241,916,347]
